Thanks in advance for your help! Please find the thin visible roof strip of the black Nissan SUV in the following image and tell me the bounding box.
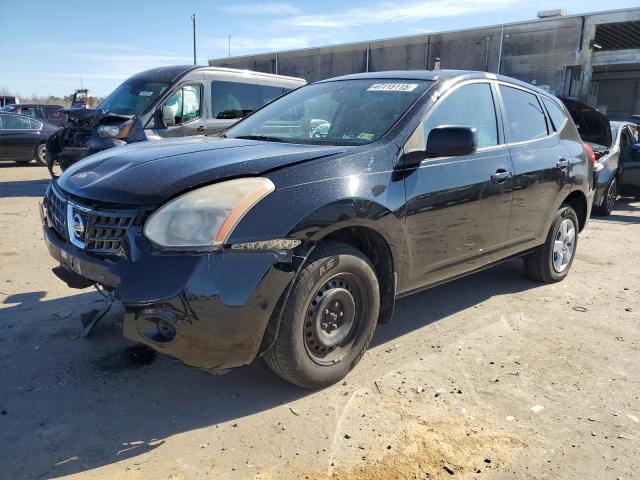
[316,69,553,96]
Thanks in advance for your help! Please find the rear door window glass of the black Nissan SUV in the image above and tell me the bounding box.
[500,85,549,143]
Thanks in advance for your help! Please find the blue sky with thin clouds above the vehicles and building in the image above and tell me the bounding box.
[0,0,638,96]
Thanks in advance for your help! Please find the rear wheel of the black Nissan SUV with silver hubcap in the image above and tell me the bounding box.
[523,204,579,283]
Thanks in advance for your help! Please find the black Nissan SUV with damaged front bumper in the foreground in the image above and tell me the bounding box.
[43,71,593,388]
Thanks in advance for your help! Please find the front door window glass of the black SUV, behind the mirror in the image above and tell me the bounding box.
[424,83,498,148]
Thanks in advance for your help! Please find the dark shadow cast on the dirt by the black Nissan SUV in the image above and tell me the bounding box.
[0,261,538,480]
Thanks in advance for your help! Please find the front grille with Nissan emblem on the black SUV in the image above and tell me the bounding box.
[46,185,137,254]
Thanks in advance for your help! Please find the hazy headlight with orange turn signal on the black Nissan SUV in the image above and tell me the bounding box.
[143,178,275,250]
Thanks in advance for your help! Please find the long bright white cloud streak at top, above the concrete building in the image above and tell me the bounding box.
[281,0,518,28]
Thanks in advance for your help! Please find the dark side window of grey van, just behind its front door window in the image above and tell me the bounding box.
[211,81,259,119]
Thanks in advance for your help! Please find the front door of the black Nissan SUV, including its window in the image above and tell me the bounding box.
[403,81,513,291]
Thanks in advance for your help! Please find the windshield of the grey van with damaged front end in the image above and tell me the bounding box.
[98,79,169,115]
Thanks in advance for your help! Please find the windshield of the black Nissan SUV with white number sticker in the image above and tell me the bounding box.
[226,79,432,145]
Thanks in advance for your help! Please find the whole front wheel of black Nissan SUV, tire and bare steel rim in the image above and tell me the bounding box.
[264,242,380,389]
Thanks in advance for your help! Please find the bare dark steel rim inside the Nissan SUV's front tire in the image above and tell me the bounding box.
[303,273,366,365]
